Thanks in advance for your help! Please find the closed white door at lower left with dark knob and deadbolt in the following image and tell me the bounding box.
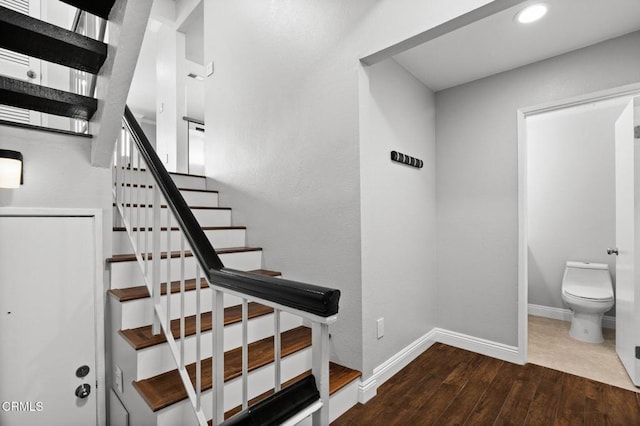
[0,216,97,426]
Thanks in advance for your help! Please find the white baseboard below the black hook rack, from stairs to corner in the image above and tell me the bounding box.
[358,329,436,404]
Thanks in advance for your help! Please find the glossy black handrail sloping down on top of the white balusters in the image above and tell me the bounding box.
[124,107,340,318]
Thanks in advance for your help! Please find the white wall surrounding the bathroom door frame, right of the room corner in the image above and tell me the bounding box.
[436,33,640,346]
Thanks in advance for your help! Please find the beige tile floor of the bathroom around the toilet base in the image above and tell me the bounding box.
[528,315,640,392]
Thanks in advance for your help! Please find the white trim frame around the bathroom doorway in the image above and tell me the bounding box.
[517,83,640,364]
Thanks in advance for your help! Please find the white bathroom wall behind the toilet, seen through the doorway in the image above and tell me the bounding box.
[527,100,624,315]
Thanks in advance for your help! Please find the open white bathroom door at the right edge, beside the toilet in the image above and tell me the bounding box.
[615,100,640,386]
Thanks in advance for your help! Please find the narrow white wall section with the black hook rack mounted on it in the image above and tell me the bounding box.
[360,59,436,378]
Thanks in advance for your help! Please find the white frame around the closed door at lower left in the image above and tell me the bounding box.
[0,208,107,426]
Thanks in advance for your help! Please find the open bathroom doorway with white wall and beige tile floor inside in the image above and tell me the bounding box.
[518,85,640,390]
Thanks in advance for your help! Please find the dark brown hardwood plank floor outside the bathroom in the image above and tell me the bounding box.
[332,343,640,426]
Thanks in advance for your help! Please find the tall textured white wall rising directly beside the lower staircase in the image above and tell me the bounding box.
[204,0,509,370]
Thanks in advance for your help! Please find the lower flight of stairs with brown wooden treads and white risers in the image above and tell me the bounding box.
[107,161,360,425]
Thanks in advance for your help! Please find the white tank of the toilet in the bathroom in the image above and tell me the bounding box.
[562,261,613,299]
